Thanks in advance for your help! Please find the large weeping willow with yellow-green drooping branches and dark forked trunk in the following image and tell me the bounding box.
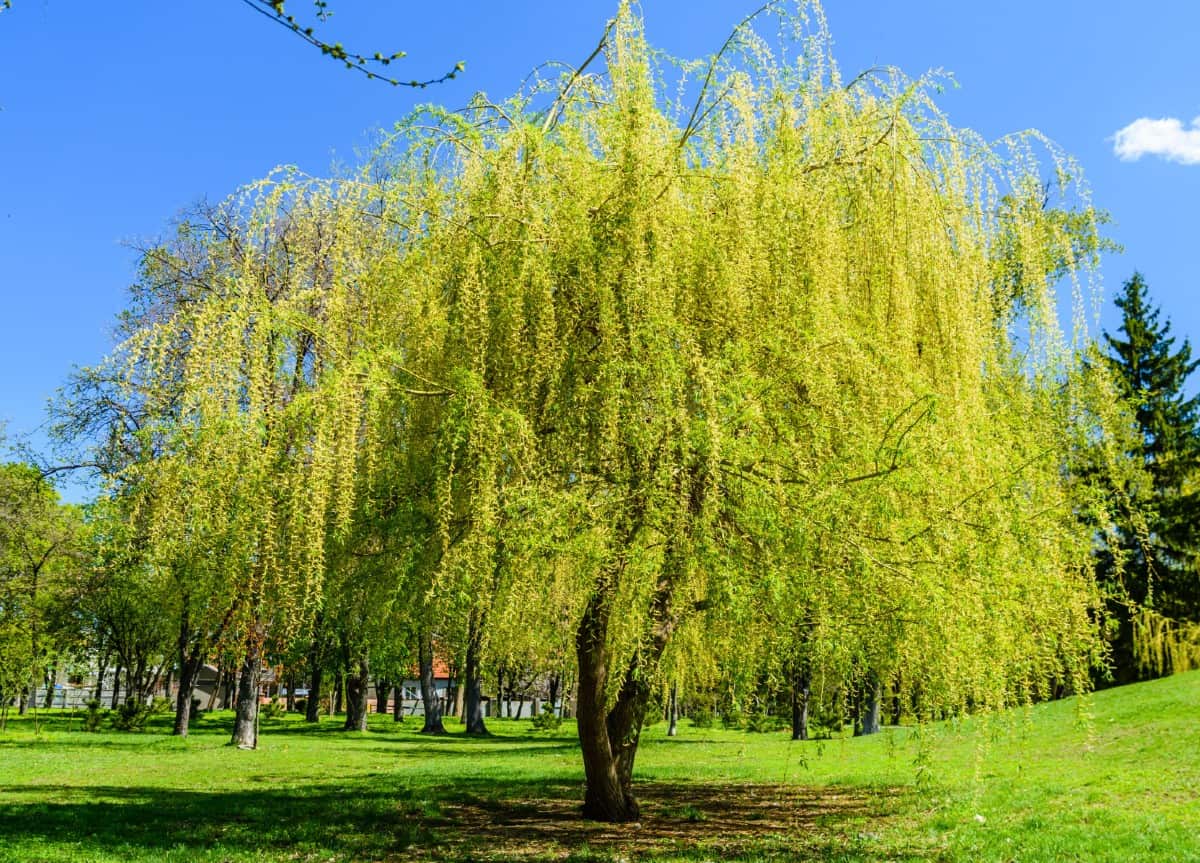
[105,0,1123,821]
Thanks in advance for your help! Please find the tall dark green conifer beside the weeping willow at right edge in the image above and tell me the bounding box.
[1102,272,1200,679]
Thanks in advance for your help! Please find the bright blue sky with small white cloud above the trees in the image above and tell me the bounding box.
[0,0,1200,496]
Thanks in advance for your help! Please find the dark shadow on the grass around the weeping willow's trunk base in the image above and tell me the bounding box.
[0,773,916,863]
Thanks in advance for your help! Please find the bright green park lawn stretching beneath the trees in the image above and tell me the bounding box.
[0,672,1200,863]
